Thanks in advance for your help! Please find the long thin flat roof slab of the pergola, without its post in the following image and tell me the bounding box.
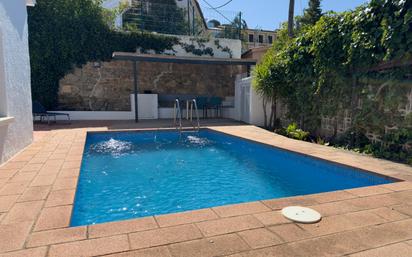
[113,52,257,66]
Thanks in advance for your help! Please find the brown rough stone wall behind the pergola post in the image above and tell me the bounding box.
[58,61,241,111]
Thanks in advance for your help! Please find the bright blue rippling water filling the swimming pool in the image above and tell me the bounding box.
[71,130,393,226]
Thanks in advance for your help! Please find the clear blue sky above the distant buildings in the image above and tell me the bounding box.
[198,0,368,30]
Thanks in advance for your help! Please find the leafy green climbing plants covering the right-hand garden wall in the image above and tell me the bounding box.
[254,0,412,164]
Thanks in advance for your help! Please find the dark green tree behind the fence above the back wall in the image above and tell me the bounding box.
[123,0,189,35]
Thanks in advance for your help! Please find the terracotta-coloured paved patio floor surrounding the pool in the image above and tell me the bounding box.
[0,121,412,257]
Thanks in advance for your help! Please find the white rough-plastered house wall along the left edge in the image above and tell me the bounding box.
[0,0,35,163]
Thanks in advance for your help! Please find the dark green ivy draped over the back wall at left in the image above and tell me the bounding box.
[28,0,178,108]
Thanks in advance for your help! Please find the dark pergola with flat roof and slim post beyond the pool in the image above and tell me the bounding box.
[112,52,257,123]
